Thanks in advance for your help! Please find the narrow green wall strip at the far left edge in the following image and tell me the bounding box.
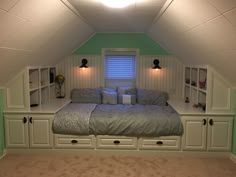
[0,89,5,156]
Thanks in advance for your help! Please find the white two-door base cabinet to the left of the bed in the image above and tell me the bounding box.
[5,114,53,148]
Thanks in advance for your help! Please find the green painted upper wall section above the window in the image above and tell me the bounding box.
[73,33,169,55]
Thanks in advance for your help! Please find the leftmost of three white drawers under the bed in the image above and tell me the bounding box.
[55,134,95,149]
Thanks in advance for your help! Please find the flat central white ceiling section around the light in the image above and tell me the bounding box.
[68,0,166,32]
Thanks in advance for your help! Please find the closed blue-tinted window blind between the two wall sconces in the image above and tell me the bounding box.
[105,55,136,80]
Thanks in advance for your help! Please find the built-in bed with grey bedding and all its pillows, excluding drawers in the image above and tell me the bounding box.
[53,88,183,137]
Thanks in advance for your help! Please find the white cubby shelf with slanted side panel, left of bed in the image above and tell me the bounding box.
[4,66,56,111]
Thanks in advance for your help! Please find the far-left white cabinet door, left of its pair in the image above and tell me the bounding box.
[5,116,29,148]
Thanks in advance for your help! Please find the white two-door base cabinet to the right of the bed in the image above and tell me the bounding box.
[182,116,233,151]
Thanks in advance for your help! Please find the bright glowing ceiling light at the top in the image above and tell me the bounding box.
[100,0,142,8]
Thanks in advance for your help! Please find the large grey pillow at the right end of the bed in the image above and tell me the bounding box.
[137,89,168,106]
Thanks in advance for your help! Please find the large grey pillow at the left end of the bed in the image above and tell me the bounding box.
[71,88,102,104]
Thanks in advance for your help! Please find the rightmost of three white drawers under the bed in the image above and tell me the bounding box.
[139,136,180,150]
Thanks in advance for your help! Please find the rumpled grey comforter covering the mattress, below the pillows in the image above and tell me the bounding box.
[53,103,183,137]
